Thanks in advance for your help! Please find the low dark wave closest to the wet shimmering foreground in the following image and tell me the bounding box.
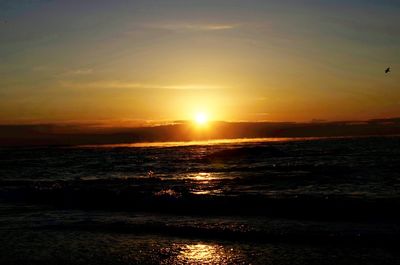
[36,220,400,246]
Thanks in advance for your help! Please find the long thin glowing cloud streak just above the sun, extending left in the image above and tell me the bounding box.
[60,81,225,90]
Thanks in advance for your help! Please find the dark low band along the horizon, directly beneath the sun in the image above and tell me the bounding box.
[0,118,400,147]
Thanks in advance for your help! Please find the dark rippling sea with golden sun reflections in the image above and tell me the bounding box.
[0,136,400,265]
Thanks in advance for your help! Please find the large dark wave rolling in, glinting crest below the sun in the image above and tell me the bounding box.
[0,178,400,220]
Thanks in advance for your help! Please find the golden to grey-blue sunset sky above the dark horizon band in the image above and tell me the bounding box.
[0,0,400,124]
